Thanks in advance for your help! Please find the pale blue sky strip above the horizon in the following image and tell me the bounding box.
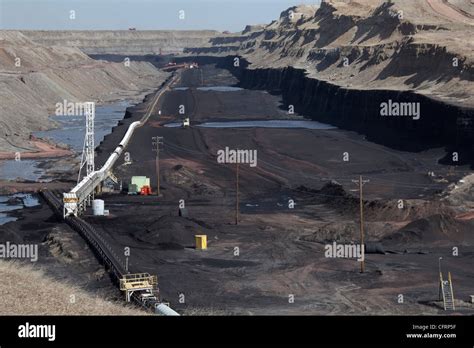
[0,0,319,31]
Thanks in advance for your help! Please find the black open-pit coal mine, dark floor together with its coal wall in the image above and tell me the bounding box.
[0,55,474,315]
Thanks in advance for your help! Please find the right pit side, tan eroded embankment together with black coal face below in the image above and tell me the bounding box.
[181,0,474,165]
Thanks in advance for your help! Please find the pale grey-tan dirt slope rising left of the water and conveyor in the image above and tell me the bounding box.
[0,31,168,157]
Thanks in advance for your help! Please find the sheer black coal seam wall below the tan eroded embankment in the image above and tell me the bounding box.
[178,56,474,167]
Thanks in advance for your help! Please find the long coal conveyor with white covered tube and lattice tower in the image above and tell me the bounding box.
[52,76,183,315]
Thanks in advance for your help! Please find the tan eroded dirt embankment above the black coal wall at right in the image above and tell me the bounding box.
[186,0,474,109]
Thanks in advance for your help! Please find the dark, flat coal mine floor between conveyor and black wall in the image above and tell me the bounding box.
[2,65,474,315]
